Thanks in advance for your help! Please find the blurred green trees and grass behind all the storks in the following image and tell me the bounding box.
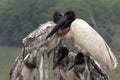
[0,0,120,80]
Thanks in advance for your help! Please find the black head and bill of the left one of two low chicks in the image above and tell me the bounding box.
[53,46,69,69]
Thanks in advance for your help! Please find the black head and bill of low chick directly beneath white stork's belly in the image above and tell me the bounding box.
[69,52,85,70]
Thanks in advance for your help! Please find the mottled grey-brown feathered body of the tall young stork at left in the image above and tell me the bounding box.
[10,21,60,80]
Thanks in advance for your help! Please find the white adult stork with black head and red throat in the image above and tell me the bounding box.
[46,10,117,70]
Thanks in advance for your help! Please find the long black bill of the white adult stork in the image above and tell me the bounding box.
[46,16,67,39]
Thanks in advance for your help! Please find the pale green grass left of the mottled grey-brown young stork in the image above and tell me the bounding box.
[0,46,21,80]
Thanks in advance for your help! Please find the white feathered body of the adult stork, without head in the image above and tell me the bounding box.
[65,19,117,70]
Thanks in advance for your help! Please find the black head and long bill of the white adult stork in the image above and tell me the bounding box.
[46,10,75,38]
